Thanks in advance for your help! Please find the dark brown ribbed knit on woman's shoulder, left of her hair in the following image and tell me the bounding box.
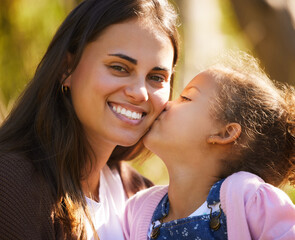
[0,154,55,239]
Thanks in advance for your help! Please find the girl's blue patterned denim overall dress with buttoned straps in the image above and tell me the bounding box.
[148,179,227,240]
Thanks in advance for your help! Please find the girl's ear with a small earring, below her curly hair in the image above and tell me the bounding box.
[207,123,242,144]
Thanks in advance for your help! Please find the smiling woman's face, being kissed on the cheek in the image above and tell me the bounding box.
[64,20,174,146]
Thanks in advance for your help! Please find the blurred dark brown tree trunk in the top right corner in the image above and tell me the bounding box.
[231,0,295,84]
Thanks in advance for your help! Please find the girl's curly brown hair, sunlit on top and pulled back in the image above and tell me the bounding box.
[207,52,295,186]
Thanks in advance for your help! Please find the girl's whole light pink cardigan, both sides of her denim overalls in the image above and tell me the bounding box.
[123,172,295,240]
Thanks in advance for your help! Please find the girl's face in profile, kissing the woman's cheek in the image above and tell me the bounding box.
[143,72,218,158]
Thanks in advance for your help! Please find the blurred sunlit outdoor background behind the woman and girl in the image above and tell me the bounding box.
[0,0,295,201]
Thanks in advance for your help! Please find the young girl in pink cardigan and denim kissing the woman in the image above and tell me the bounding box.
[124,54,295,240]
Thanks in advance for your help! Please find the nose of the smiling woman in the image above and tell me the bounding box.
[125,81,149,102]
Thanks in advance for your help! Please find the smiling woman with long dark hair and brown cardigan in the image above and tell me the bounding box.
[0,0,178,239]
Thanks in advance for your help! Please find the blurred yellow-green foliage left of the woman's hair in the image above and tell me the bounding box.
[0,0,73,106]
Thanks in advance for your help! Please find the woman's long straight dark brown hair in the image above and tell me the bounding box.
[0,0,178,239]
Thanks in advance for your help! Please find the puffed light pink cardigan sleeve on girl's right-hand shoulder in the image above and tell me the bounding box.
[220,172,295,240]
